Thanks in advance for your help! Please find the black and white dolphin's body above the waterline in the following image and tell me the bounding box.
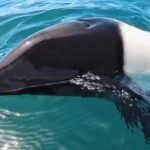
[0,18,150,94]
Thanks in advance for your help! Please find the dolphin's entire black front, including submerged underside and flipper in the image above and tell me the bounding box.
[0,18,150,141]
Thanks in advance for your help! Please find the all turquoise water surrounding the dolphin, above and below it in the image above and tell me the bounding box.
[0,0,150,150]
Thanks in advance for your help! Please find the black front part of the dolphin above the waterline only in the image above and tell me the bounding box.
[0,19,123,93]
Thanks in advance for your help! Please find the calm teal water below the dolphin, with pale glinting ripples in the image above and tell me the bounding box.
[0,95,148,150]
